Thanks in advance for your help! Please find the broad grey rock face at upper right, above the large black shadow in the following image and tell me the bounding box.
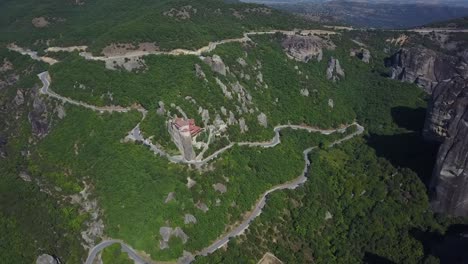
[385,48,468,94]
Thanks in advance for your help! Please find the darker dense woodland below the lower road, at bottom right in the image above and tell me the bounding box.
[199,139,441,263]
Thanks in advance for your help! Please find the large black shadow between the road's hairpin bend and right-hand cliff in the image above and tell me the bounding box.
[367,107,439,187]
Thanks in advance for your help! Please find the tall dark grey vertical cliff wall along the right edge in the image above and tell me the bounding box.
[426,77,468,216]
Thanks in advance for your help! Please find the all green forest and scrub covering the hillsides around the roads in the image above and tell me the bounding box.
[0,0,464,264]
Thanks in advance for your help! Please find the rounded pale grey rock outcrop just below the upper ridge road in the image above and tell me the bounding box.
[281,35,336,62]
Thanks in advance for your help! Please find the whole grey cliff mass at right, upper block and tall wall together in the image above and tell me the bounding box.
[386,48,468,216]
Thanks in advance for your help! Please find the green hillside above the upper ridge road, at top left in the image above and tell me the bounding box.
[0,0,316,53]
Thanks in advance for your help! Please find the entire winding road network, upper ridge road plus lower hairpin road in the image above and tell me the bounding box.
[14,23,468,264]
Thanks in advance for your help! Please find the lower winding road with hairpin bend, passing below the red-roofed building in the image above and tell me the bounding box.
[38,71,364,264]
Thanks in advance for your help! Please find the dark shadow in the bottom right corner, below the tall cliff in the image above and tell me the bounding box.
[410,225,468,264]
